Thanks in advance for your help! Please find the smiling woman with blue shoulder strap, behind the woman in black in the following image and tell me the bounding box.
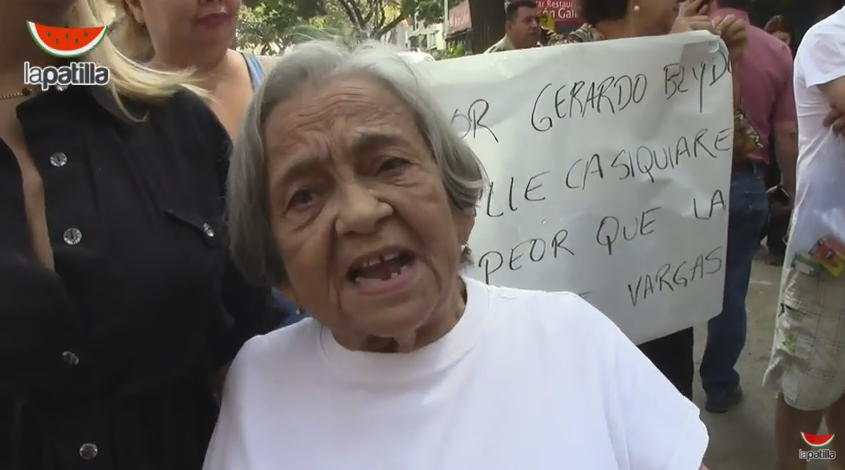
[108,0,303,324]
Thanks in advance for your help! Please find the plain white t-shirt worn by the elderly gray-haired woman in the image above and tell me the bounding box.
[205,279,708,470]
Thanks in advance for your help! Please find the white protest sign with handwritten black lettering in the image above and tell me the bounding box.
[415,32,733,343]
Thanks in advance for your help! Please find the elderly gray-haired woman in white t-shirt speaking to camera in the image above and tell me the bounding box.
[204,42,708,470]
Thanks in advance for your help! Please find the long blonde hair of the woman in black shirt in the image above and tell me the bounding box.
[68,0,203,120]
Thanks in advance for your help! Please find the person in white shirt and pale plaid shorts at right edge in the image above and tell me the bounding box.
[764,8,845,470]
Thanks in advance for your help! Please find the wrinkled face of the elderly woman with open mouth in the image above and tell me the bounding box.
[264,75,474,338]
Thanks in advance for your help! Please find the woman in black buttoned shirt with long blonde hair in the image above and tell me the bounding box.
[0,0,280,470]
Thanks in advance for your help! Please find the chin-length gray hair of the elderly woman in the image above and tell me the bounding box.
[227,41,486,285]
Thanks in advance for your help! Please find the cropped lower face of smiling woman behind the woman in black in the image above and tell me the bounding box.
[126,0,241,57]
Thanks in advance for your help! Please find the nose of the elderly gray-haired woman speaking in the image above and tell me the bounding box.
[336,183,393,235]
